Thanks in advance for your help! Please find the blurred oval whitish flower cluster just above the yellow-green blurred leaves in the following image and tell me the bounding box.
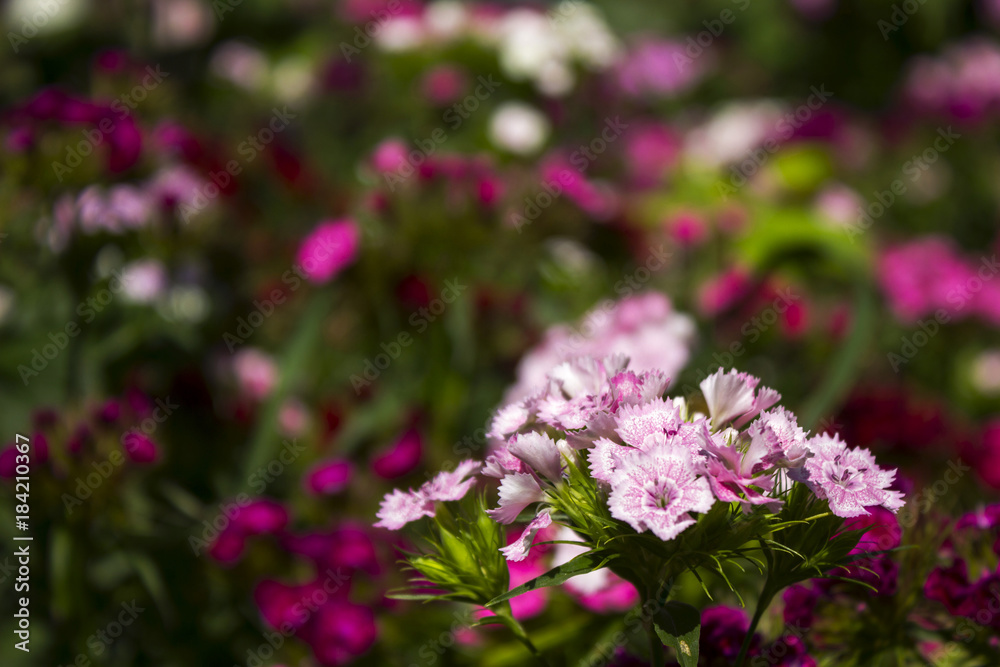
[684,100,784,168]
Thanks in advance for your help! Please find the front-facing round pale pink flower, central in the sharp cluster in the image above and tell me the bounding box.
[608,447,715,540]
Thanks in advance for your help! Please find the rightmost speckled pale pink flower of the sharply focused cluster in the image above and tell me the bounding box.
[790,434,905,518]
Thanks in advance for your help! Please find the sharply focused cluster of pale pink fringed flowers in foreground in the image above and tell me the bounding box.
[379,355,903,561]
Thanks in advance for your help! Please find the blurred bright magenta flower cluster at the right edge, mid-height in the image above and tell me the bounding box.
[878,236,1000,325]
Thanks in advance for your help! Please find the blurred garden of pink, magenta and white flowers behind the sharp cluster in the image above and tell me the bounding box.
[0,0,1000,667]
